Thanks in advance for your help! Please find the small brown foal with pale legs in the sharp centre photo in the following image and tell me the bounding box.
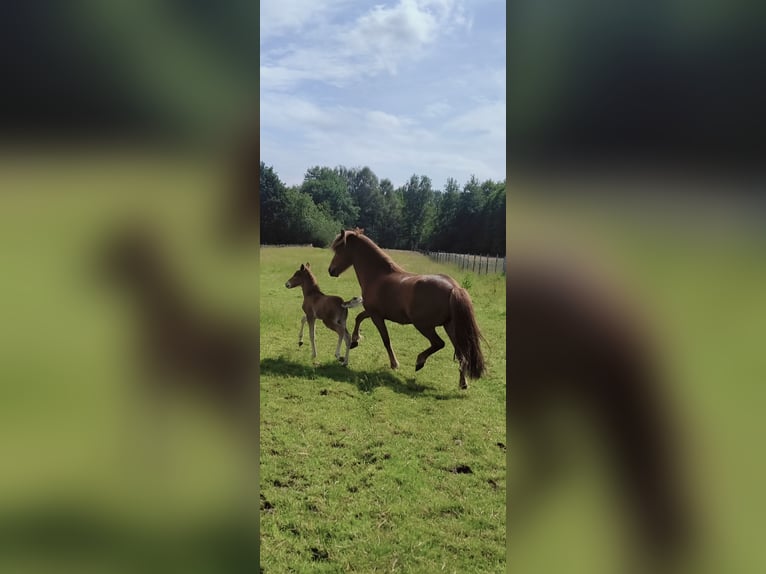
[285,263,362,365]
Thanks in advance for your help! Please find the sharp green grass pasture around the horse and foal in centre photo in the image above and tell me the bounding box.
[260,247,506,573]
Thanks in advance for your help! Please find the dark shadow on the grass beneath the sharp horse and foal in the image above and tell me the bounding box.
[261,357,465,400]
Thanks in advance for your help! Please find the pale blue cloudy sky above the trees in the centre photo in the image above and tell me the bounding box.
[260,0,505,189]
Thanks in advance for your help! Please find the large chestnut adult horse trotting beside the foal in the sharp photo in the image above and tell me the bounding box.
[328,228,485,389]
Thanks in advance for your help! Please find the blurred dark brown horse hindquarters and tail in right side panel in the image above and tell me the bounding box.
[507,256,692,572]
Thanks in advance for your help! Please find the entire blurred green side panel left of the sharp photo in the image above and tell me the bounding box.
[0,0,258,572]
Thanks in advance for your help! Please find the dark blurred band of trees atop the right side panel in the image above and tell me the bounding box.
[508,0,766,178]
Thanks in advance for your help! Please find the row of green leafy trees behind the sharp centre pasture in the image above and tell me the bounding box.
[260,161,505,255]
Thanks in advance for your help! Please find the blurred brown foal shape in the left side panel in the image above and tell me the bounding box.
[100,225,257,424]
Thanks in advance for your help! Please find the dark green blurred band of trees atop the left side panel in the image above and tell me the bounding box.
[0,0,258,144]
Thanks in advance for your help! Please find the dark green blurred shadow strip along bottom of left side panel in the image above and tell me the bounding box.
[0,501,258,573]
